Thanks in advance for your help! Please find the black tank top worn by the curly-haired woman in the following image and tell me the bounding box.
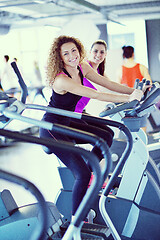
[43,66,83,125]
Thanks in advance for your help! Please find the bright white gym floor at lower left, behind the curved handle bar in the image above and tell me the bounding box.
[0,137,61,206]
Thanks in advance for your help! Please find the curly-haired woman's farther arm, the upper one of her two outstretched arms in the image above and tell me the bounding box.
[82,63,134,94]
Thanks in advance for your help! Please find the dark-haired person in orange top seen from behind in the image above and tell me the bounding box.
[119,46,151,87]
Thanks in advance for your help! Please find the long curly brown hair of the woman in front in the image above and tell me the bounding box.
[46,35,86,87]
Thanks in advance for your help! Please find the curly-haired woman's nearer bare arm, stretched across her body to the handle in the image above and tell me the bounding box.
[53,75,143,102]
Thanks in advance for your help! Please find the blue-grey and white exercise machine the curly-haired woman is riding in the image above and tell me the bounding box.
[56,79,160,240]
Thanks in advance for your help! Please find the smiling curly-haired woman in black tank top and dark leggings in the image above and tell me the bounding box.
[40,36,143,225]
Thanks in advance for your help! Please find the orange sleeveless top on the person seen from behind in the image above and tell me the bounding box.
[121,63,143,87]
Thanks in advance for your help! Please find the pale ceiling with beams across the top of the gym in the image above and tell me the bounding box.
[0,0,160,34]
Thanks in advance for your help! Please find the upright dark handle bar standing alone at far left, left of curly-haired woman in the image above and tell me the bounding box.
[11,62,28,103]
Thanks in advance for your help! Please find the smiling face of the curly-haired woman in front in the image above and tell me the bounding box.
[61,42,80,67]
